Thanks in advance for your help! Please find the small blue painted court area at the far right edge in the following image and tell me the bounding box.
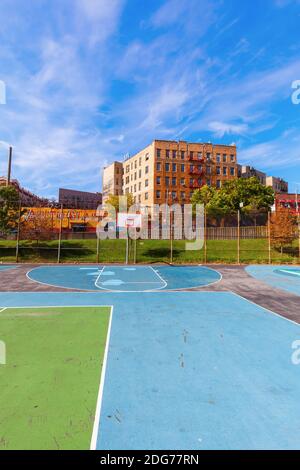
[246,265,300,295]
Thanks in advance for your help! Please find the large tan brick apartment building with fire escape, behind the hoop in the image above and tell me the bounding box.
[103,140,238,206]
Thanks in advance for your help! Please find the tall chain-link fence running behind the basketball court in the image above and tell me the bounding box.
[0,207,300,264]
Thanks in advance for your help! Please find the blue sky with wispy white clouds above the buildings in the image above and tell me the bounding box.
[0,0,300,197]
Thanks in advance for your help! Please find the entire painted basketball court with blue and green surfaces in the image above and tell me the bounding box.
[0,265,300,450]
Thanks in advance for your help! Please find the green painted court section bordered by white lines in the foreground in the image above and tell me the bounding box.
[0,307,111,450]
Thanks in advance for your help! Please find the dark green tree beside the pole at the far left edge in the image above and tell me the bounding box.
[0,186,24,234]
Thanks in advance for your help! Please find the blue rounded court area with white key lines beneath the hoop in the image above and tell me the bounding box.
[27,265,221,292]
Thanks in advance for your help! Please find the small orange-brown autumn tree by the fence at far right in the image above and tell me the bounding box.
[270,209,297,253]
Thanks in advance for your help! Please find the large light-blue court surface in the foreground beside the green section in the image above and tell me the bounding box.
[0,291,300,450]
